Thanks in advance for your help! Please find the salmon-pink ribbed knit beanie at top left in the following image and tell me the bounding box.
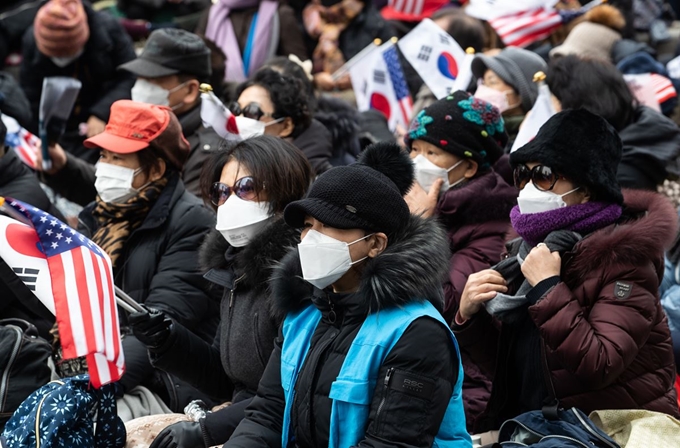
[33,0,90,57]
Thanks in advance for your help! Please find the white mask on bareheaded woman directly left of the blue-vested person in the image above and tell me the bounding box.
[215,194,272,247]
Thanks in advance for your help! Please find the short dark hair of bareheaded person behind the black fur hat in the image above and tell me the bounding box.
[546,55,638,131]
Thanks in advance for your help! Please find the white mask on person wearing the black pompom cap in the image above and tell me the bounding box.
[298,229,373,289]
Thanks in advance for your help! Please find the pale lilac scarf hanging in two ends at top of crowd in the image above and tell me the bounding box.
[205,0,279,82]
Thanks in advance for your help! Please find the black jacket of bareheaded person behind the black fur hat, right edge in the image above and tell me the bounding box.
[616,107,680,191]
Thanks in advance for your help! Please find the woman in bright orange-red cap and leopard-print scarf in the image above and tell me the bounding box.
[79,100,219,419]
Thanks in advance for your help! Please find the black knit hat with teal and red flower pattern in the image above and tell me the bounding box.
[405,90,508,169]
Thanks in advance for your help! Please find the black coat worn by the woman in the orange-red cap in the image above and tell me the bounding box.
[79,173,219,411]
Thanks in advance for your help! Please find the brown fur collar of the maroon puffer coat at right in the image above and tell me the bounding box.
[572,190,678,278]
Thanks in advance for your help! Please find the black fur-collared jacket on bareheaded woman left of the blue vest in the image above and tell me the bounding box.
[151,218,300,445]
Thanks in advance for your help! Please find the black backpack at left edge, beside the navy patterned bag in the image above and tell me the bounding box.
[0,319,52,431]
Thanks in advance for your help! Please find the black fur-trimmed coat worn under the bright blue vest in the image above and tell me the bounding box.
[225,216,460,448]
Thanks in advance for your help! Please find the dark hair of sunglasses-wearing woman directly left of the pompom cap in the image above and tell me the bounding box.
[201,135,313,213]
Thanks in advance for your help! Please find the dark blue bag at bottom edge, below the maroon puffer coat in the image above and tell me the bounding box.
[498,408,621,448]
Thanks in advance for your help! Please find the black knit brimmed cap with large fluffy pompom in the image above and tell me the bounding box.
[283,142,413,234]
